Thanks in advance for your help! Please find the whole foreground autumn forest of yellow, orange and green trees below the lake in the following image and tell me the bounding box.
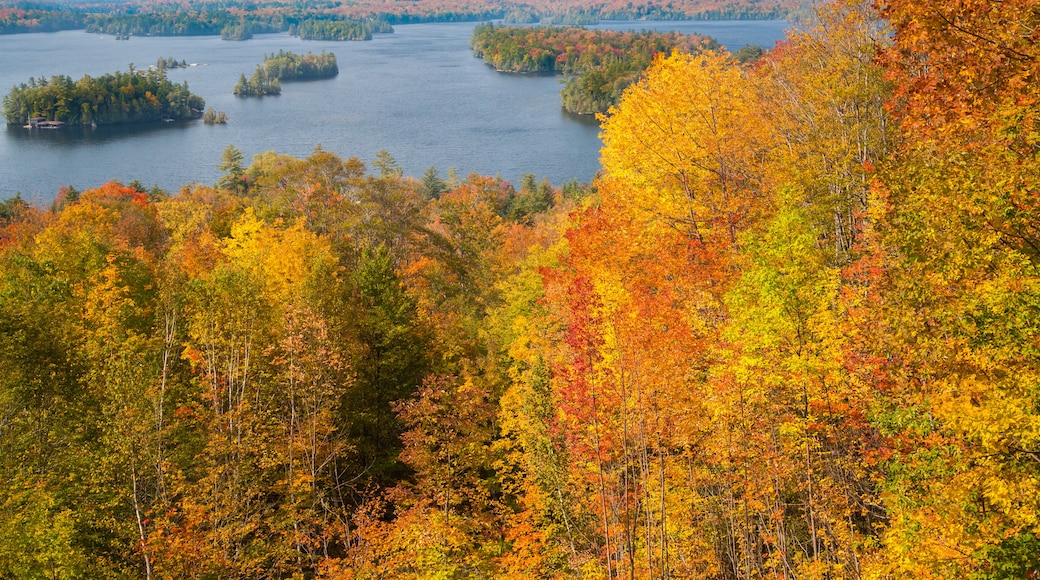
[0,0,1040,580]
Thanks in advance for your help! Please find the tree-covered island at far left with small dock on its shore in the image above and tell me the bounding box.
[3,67,206,125]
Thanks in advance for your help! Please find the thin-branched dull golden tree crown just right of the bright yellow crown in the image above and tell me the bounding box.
[755,0,894,258]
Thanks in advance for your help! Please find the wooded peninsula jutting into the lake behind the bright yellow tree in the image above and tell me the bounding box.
[470,23,719,114]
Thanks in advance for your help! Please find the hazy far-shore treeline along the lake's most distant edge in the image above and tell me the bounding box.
[0,0,801,39]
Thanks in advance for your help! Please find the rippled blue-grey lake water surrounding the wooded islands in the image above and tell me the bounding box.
[0,21,787,204]
